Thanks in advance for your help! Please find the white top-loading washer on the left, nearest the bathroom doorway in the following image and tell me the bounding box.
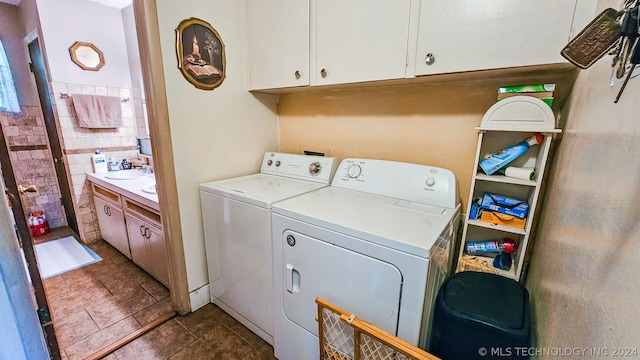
[200,152,338,344]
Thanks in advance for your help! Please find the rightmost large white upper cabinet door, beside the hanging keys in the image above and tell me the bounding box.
[415,0,582,75]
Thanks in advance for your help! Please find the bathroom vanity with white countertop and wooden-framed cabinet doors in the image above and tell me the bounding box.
[87,169,169,287]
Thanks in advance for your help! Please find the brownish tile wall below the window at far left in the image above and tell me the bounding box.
[0,106,67,228]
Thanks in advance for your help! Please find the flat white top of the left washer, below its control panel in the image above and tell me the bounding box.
[200,174,327,208]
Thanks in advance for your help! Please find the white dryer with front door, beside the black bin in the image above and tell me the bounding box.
[272,158,460,360]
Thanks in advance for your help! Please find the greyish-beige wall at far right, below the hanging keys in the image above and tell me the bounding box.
[527,1,640,352]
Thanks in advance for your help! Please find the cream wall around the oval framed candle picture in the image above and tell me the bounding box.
[150,0,278,309]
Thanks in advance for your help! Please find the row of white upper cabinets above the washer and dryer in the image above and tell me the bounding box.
[245,0,597,90]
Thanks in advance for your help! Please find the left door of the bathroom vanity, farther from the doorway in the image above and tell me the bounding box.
[93,196,131,259]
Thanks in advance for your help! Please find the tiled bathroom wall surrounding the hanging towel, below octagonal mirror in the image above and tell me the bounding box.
[51,82,137,243]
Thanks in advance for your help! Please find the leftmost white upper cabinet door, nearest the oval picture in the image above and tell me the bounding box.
[246,0,309,90]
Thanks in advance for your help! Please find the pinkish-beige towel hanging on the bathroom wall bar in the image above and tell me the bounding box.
[71,94,122,129]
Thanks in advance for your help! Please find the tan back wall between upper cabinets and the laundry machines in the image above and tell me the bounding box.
[278,73,572,212]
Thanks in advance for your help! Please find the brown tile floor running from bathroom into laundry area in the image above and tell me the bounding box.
[38,229,275,360]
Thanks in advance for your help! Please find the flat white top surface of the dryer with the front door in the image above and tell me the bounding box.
[272,186,460,258]
